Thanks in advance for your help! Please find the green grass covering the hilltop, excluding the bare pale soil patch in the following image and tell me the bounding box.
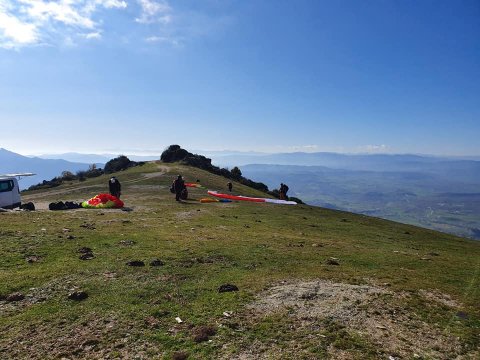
[0,163,480,358]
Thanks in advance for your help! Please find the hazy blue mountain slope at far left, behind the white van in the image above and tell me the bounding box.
[0,148,103,189]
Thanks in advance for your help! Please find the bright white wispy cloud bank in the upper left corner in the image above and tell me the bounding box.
[0,0,188,49]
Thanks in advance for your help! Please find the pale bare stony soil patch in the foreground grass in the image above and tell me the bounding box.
[233,280,472,359]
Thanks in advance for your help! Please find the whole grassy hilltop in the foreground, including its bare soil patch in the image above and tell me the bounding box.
[0,162,480,359]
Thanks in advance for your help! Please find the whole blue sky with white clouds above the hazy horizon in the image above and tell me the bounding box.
[0,0,480,156]
